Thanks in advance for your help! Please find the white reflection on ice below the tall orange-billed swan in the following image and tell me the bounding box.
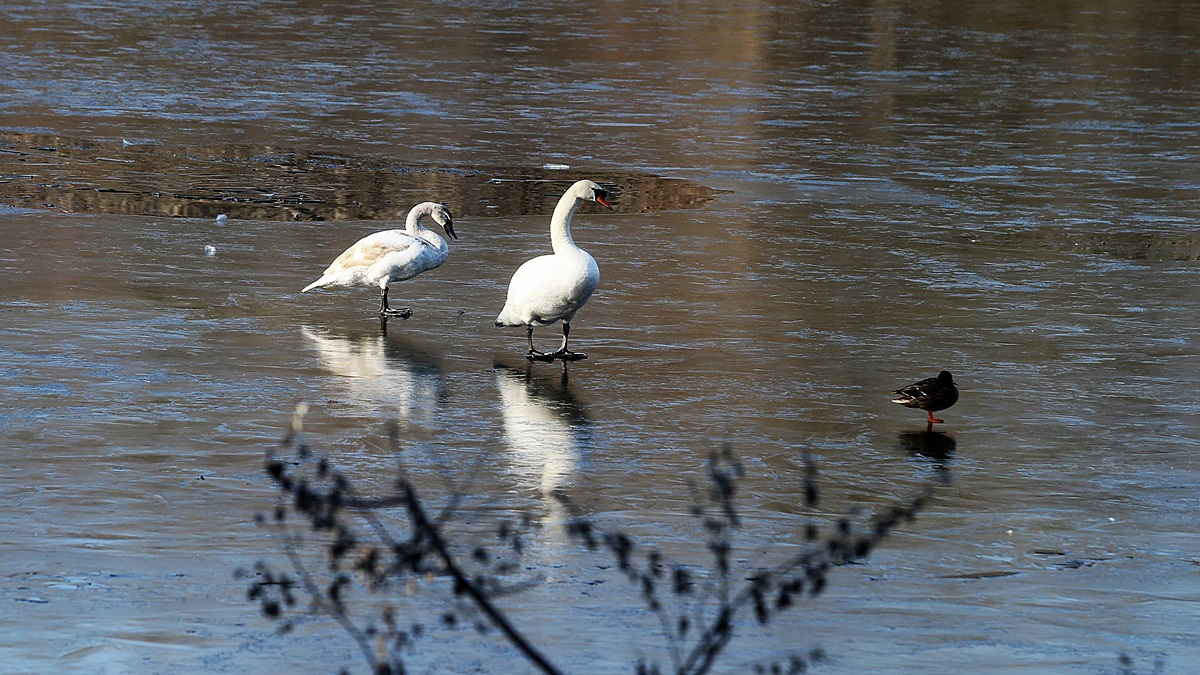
[494,363,590,521]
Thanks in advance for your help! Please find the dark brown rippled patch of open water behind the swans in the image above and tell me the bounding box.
[0,132,715,220]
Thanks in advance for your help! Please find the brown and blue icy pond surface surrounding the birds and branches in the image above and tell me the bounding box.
[0,0,1200,673]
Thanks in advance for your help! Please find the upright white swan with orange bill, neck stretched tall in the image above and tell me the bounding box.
[496,180,612,360]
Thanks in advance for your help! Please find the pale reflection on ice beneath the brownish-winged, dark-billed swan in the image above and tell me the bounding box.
[300,325,445,426]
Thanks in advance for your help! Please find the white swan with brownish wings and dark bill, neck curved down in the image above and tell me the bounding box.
[300,202,458,318]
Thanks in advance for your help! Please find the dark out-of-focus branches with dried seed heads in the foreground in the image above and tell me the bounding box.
[250,415,930,675]
